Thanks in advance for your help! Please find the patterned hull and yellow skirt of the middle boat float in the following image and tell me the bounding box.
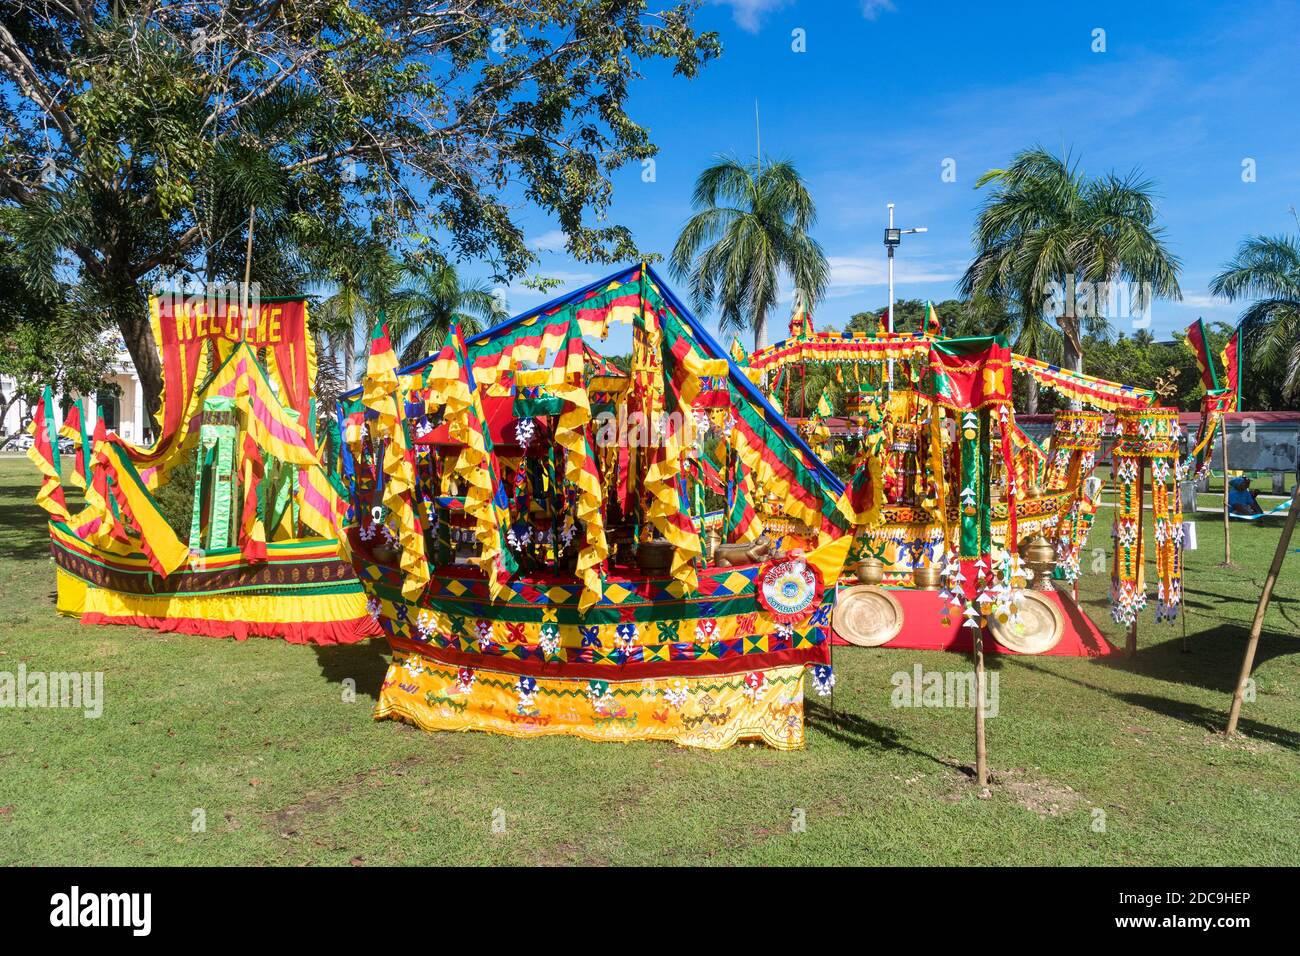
[358,537,852,750]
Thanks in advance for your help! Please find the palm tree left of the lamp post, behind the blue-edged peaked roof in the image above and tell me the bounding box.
[671,156,831,349]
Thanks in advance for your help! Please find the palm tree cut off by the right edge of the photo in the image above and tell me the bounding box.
[1210,235,1300,399]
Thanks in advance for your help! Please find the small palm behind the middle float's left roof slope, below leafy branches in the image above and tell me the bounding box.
[387,256,506,364]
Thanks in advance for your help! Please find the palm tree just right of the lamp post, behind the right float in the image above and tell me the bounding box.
[961,147,1182,372]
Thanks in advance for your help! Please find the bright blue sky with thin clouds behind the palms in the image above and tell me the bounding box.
[493,0,1300,351]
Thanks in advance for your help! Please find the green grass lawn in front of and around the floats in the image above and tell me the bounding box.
[0,458,1300,865]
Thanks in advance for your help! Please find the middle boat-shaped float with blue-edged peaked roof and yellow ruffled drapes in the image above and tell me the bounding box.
[339,265,854,749]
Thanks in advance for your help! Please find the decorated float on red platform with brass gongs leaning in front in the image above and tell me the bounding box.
[733,307,1221,657]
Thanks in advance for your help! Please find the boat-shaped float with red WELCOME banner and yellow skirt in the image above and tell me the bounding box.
[29,297,377,644]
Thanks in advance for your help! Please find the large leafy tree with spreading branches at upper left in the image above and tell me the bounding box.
[0,0,719,416]
